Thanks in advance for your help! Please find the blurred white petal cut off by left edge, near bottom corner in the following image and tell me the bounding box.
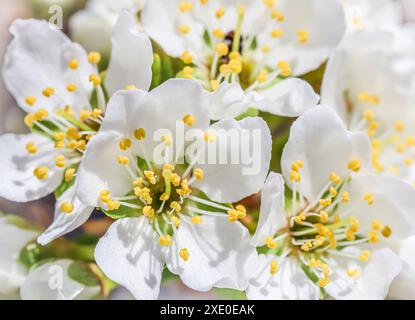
[0,217,38,295]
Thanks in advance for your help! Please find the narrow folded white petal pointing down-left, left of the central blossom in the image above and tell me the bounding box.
[37,186,94,245]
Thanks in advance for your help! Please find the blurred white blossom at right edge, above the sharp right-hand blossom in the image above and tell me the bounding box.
[321,31,415,183]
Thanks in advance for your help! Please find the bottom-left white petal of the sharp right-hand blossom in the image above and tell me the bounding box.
[246,255,320,300]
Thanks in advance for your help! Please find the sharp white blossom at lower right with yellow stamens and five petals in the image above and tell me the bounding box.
[247,106,415,299]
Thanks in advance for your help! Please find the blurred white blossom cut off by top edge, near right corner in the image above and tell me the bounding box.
[341,0,404,32]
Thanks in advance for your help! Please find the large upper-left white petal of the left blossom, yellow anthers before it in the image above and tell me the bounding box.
[3,19,93,112]
